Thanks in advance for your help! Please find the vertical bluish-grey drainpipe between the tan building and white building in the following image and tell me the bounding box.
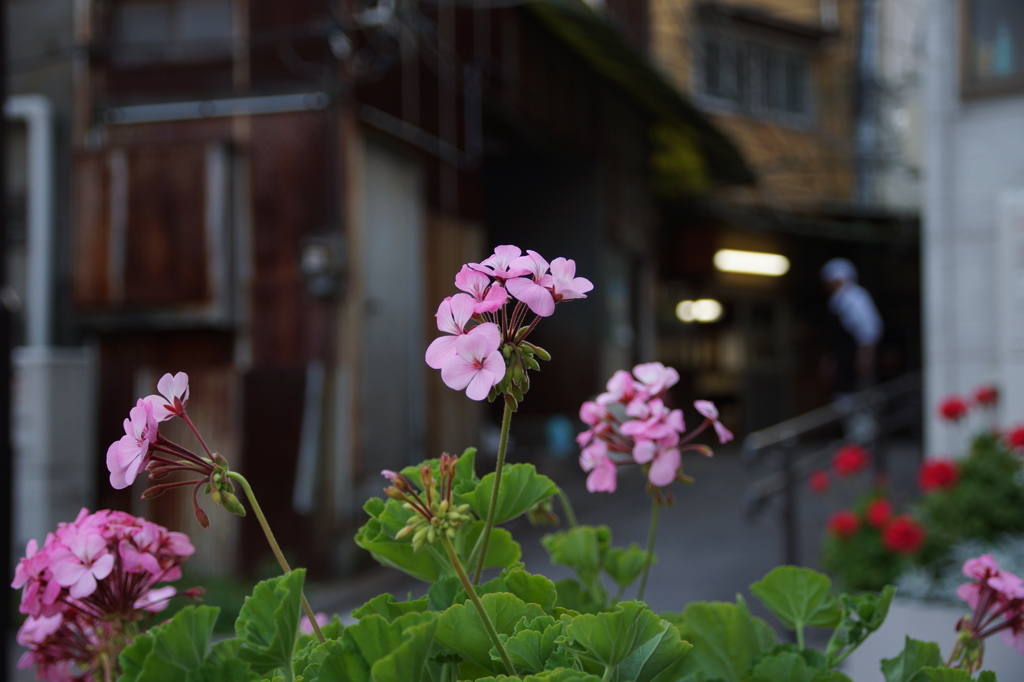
[856,0,879,205]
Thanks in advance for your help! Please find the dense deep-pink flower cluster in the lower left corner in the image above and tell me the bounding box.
[11,509,198,681]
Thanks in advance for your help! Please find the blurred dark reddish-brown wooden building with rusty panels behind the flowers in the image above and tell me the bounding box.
[11,0,751,572]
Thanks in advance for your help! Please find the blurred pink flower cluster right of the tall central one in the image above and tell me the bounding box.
[577,363,732,493]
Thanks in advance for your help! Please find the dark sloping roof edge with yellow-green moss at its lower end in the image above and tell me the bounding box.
[526,0,755,191]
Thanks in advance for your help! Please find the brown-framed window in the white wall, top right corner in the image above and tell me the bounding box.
[963,0,1024,93]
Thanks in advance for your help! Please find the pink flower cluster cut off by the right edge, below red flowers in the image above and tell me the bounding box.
[956,554,1024,654]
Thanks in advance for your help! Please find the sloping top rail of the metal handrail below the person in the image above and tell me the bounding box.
[743,372,921,459]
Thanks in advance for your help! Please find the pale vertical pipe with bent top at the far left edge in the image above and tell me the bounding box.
[4,94,54,346]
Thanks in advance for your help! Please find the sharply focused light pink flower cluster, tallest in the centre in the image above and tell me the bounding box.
[426,245,594,400]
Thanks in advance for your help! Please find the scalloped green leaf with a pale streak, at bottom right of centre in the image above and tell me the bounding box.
[562,601,691,682]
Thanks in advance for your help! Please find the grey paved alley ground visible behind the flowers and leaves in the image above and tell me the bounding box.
[8,442,920,680]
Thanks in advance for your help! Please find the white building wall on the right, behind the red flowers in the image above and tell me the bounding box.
[922,0,1024,455]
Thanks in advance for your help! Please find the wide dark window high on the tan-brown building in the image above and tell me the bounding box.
[698,34,811,120]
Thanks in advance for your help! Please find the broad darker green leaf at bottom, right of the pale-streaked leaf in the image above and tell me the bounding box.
[662,602,775,682]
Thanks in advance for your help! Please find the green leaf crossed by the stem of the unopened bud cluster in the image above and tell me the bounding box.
[435,592,544,674]
